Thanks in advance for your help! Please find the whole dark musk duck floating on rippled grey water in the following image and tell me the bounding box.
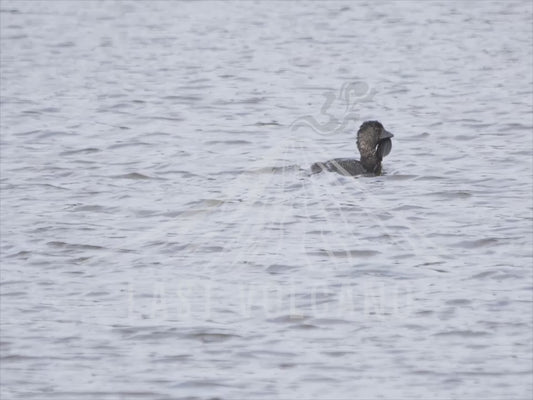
[311,121,394,175]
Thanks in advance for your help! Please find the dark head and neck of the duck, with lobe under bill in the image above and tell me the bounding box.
[357,121,394,174]
